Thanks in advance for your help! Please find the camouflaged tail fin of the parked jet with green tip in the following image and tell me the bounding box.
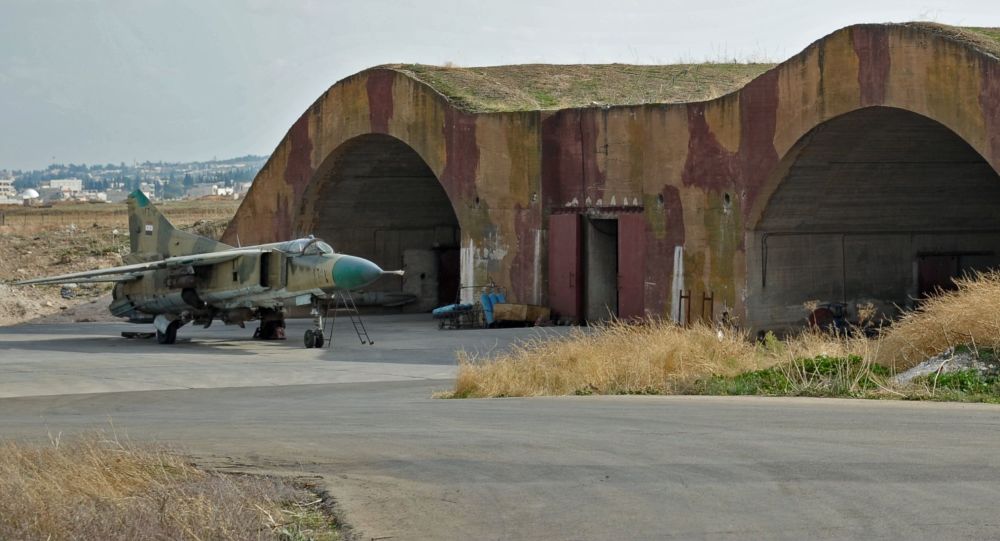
[126,190,232,263]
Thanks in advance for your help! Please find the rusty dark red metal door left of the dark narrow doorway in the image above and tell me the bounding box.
[549,214,583,320]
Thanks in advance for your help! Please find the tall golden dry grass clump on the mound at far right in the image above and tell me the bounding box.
[876,272,1000,371]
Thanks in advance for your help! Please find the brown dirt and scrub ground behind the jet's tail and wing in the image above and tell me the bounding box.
[0,200,239,326]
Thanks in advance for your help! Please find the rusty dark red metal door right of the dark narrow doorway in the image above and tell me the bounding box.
[618,213,646,319]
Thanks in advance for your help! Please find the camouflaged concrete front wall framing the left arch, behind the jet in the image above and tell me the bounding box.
[226,69,545,303]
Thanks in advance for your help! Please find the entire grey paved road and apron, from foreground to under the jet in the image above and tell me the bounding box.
[0,318,1000,540]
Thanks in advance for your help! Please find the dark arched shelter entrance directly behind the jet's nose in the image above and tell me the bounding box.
[304,134,461,311]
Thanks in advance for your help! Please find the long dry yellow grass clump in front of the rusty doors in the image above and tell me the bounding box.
[451,320,870,397]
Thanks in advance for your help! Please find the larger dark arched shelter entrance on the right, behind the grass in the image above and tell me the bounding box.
[747,107,1000,329]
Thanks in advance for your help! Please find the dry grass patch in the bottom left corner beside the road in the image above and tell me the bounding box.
[0,434,336,540]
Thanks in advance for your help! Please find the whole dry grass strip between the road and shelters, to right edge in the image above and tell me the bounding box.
[445,272,1000,400]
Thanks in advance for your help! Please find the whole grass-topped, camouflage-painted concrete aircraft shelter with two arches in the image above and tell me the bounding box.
[226,23,1000,329]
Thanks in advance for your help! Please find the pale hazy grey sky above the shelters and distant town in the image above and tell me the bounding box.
[0,0,1000,169]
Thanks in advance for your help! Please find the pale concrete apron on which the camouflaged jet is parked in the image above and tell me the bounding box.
[0,314,566,398]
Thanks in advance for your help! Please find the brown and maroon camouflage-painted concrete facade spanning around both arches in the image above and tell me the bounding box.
[225,24,1000,316]
